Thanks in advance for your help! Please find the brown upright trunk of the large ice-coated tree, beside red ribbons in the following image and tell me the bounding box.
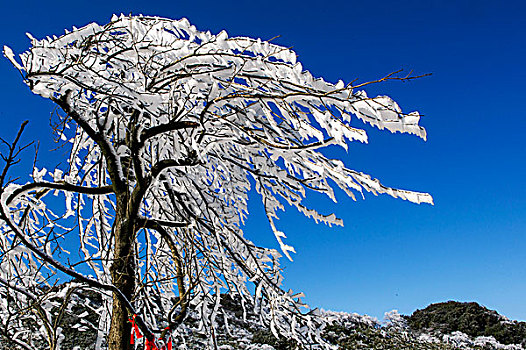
[108,206,136,350]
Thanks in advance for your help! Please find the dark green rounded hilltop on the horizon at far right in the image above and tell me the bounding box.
[407,301,526,346]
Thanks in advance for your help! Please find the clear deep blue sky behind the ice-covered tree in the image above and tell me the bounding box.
[0,0,526,320]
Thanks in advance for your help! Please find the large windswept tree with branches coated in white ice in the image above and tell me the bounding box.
[0,16,432,349]
